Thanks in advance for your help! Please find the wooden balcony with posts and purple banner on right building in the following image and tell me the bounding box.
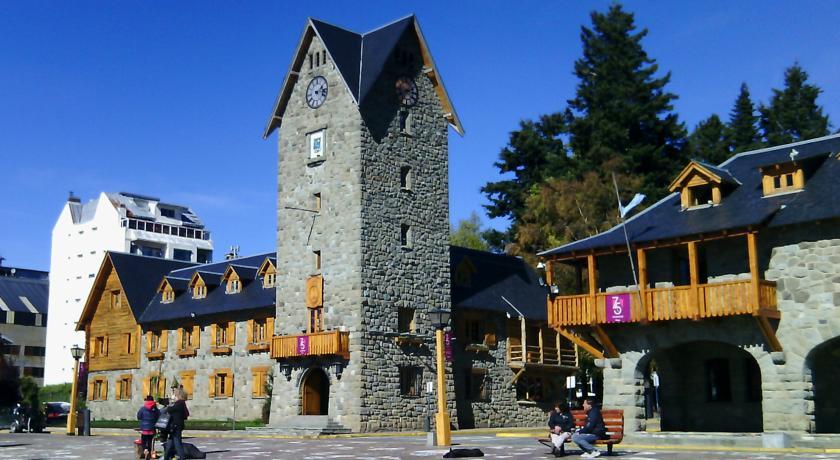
[544,231,781,354]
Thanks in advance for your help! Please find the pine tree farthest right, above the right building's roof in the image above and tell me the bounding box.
[759,63,831,145]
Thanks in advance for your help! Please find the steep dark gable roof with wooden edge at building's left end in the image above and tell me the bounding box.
[76,251,196,331]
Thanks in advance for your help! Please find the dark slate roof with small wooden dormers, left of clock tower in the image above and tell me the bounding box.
[139,252,276,324]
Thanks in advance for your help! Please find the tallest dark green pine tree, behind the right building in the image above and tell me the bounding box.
[567,5,685,198]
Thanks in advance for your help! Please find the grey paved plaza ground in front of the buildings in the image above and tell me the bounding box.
[0,433,840,460]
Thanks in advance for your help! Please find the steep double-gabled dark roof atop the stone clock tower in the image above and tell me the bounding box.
[263,15,464,138]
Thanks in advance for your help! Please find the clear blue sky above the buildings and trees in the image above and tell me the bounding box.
[0,0,840,269]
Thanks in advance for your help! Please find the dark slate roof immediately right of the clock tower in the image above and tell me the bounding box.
[449,246,548,320]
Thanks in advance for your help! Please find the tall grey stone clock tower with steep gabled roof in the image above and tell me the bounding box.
[264,16,463,432]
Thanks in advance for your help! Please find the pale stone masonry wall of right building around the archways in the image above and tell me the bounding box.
[600,220,840,432]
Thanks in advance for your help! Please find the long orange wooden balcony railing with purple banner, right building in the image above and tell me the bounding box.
[548,280,776,327]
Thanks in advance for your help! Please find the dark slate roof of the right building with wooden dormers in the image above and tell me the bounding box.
[539,134,840,256]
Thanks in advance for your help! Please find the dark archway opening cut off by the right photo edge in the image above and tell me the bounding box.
[806,337,840,433]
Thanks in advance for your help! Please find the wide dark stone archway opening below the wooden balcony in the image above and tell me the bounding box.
[636,341,763,433]
